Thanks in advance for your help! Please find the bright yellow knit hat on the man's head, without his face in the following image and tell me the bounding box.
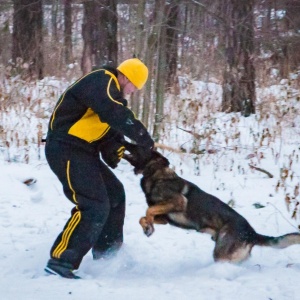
[117,58,148,90]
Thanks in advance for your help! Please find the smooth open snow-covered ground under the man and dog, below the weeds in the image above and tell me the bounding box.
[0,144,300,300]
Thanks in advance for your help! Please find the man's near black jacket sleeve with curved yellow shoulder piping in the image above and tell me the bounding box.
[79,74,154,148]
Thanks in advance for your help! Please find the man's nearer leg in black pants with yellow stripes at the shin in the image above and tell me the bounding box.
[46,142,110,278]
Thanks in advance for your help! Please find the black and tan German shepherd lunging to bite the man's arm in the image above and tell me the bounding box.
[124,143,300,263]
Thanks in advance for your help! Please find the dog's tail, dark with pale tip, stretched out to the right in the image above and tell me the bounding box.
[255,232,300,249]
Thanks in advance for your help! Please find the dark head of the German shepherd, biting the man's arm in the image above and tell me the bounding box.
[123,143,170,174]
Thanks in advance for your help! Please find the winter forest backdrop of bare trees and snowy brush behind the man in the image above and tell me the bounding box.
[0,0,300,223]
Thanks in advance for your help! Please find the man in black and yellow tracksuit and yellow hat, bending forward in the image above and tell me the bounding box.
[45,58,154,279]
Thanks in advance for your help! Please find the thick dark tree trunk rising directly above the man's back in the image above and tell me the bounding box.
[81,0,118,73]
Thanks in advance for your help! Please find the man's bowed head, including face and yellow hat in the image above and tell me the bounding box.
[117,58,148,94]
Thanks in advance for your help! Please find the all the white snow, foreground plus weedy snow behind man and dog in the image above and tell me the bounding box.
[0,78,300,300]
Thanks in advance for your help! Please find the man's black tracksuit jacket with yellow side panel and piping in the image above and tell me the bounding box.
[48,68,153,149]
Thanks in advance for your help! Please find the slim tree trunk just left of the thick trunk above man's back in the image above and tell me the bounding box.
[64,0,73,64]
